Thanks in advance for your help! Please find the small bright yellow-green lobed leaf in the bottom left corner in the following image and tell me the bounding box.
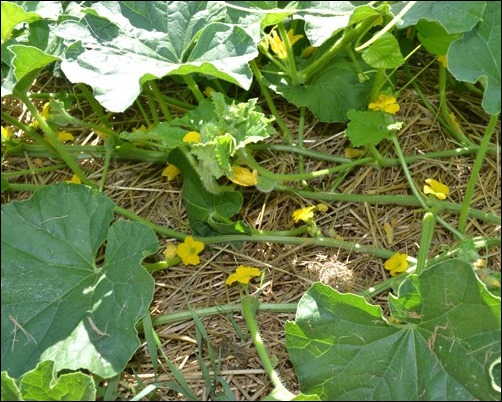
[2,360,96,401]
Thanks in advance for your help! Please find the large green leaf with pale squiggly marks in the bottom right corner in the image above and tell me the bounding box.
[286,260,500,401]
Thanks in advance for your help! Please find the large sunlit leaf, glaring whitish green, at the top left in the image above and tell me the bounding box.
[56,1,258,112]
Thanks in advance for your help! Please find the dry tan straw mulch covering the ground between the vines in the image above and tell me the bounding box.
[2,66,501,400]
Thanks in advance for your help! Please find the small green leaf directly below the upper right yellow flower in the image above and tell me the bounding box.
[345,110,399,147]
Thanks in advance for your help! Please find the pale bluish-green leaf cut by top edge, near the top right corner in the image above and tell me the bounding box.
[391,1,486,34]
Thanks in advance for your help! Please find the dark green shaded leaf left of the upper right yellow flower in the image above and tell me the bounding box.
[264,58,374,123]
